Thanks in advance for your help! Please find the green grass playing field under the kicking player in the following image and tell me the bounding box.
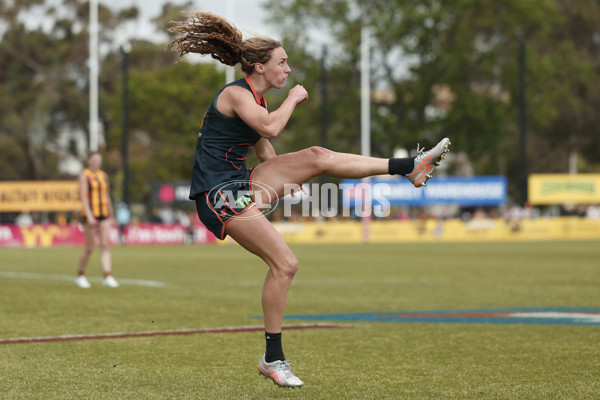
[0,242,600,400]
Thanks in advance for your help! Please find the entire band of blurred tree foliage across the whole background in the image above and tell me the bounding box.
[0,0,600,208]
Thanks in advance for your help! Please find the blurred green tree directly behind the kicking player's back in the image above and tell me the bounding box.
[103,42,225,204]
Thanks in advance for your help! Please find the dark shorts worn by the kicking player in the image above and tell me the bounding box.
[195,169,256,240]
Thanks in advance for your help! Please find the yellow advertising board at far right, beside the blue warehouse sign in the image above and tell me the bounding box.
[528,174,600,204]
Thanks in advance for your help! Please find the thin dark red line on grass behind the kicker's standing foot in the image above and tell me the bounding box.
[0,324,359,345]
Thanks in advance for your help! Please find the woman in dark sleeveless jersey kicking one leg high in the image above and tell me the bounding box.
[169,12,450,387]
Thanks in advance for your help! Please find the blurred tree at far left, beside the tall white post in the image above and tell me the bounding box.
[0,0,136,179]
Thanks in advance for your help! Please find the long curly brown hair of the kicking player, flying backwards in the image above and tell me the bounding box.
[167,12,281,75]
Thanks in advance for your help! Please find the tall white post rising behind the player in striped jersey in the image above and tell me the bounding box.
[89,0,100,151]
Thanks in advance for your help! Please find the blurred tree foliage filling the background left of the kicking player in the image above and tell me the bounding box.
[0,0,224,206]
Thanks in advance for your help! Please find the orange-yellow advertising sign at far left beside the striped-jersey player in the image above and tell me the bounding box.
[0,181,81,212]
